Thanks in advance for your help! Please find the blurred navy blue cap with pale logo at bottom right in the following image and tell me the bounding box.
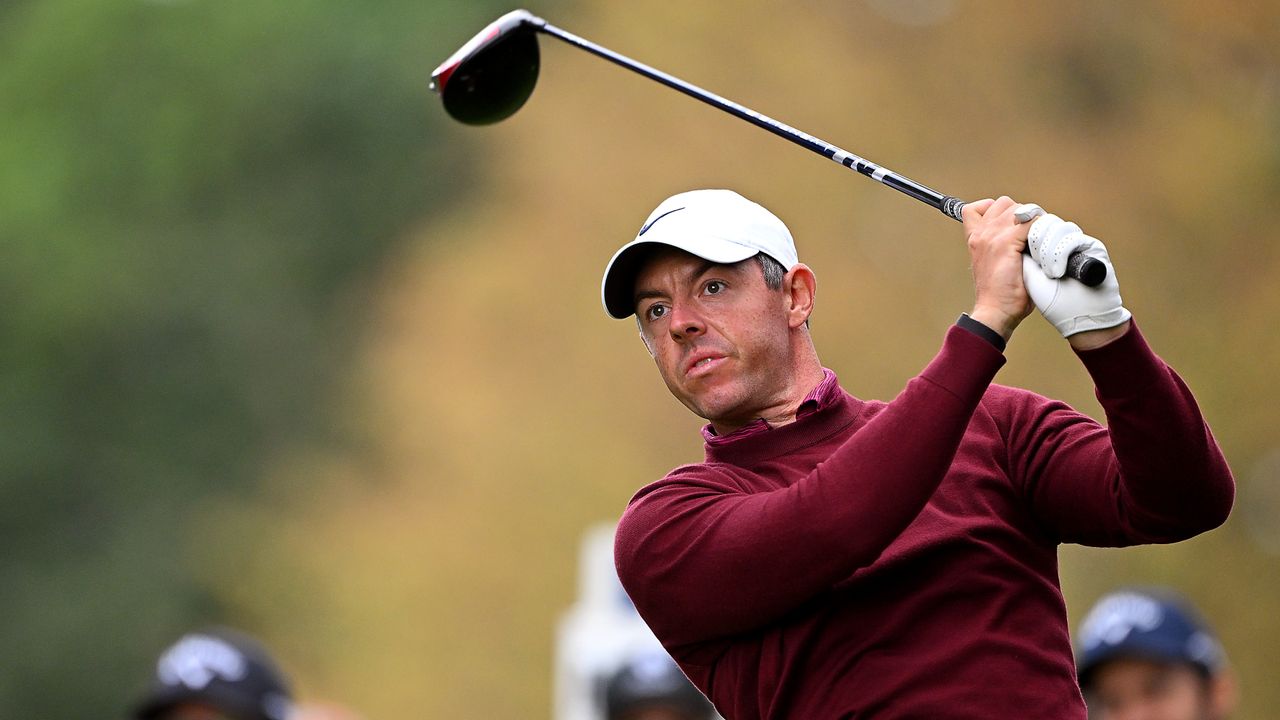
[1076,589,1226,687]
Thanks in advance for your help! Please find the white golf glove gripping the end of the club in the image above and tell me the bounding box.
[1023,214,1133,337]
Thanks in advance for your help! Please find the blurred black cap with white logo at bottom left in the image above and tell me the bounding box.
[133,628,292,720]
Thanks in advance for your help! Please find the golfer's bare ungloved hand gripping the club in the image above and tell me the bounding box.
[960,197,1034,340]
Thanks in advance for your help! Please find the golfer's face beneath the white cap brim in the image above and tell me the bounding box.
[635,249,794,429]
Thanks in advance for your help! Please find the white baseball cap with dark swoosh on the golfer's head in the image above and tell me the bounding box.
[600,190,800,320]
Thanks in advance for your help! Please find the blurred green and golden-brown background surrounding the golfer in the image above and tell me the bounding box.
[0,0,1280,719]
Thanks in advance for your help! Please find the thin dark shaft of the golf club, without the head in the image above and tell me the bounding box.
[534,18,964,220]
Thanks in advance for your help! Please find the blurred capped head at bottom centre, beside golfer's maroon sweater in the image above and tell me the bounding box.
[604,651,712,720]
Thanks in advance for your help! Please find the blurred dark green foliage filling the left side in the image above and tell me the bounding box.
[0,0,519,717]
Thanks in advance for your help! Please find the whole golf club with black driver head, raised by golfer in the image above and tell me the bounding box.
[431,10,1107,286]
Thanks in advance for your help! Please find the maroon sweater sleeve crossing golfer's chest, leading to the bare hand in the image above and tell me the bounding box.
[614,328,1004,648]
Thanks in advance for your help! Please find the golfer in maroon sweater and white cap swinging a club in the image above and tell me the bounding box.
[602,190,1234,720]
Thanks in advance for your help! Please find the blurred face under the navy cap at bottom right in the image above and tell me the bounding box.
[1087,659,1225,720]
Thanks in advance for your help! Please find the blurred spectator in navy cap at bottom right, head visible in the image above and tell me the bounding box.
[1078,591,1236,720]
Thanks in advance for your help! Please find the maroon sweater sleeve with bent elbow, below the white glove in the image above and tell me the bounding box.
[1007,320,1235,547]
